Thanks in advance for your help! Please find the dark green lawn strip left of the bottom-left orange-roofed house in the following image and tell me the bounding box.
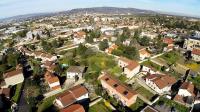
[37,95,56,112]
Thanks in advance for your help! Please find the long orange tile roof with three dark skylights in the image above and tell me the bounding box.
[99,74,137,99]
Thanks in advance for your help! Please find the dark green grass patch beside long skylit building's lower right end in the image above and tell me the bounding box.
[130,98,146,112]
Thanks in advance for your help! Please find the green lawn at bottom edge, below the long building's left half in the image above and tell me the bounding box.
[89,101,112,112]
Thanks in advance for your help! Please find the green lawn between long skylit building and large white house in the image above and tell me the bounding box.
[136,86,154,100]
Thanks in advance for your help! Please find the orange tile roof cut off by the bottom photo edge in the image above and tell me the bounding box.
[60,104,85,112]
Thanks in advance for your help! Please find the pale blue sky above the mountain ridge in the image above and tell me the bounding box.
[0,0,200,18]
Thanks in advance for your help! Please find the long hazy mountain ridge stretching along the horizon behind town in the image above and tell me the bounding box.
[0,7,198,24]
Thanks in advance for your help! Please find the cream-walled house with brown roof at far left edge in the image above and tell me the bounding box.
[2,65,24,88]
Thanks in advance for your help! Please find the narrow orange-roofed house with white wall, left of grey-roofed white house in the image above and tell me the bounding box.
[44,71,61,90]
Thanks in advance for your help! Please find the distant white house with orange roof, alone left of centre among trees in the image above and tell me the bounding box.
[74,31,86,44]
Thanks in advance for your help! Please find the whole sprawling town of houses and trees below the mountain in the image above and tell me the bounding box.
[0,7,200,112]
